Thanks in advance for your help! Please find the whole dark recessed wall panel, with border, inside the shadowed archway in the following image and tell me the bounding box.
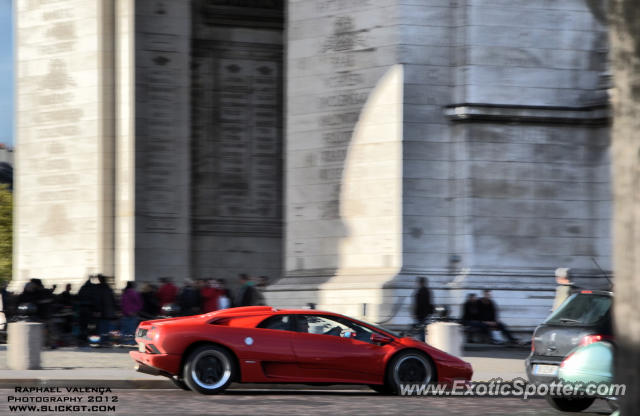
[192,37,282,233]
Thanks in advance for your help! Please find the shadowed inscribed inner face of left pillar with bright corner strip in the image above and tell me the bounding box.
[125,0,191,284]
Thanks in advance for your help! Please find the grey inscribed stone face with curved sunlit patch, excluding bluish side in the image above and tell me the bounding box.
[270,0,404,315]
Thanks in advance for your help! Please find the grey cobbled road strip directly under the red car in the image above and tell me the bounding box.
[0,390,610,416]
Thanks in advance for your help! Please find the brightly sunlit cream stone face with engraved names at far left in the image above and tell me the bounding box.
[14,0,101,280]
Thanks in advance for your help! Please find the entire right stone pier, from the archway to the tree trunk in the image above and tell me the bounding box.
[270,0,611,329]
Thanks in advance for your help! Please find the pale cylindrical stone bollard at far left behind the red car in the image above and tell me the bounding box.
[7,322,44,370]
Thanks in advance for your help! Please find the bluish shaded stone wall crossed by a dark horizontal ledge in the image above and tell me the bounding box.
[446,0,611,328]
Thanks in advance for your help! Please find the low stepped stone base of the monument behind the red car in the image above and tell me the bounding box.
[265,269,606,333]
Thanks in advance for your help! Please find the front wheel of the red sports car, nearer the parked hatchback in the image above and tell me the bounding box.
[386,351,436,394]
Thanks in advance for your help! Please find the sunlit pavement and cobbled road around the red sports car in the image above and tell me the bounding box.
[0,346,610,416]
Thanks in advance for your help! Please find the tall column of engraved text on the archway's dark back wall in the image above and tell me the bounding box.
[216,59,279,218]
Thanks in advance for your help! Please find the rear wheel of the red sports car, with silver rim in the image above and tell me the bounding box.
[182,345,235,394]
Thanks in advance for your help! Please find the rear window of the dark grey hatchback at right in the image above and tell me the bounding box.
[545,293,611,325]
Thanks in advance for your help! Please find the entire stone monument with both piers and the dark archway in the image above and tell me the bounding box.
[12,0,611,329]
